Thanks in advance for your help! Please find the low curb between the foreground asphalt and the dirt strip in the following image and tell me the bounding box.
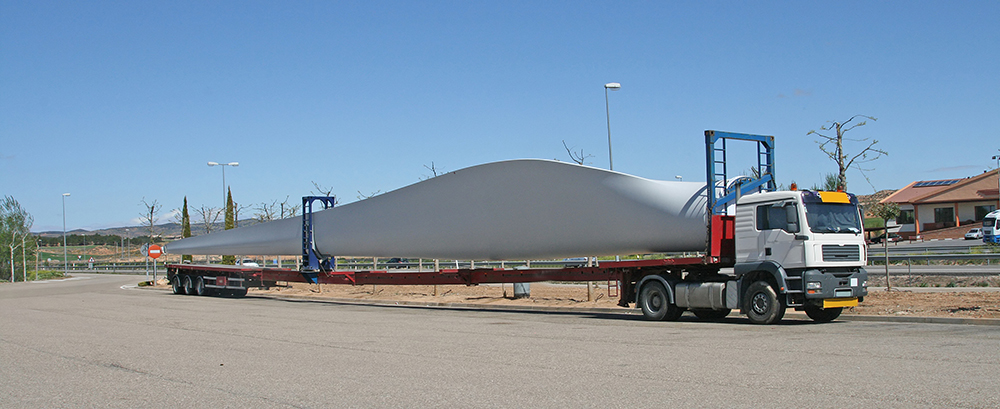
[135,287,1000,326]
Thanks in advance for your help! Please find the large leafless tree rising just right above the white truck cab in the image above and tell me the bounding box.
[806,115,888,190]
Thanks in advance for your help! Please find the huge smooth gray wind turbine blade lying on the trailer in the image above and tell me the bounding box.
[165,159,707,260]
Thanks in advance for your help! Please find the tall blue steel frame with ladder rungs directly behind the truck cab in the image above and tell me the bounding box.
[705,131,778,215]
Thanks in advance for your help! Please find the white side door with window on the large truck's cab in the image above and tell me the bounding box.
[756,202,805,268]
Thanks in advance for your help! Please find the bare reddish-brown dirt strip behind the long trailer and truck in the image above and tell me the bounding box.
[178,276,1000,318]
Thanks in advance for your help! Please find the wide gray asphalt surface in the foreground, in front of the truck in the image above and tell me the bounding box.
[0,275,1000,408]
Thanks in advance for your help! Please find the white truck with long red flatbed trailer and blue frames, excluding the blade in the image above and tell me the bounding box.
[167,131,868,324]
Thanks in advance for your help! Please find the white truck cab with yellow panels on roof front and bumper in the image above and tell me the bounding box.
[734,190,868,322]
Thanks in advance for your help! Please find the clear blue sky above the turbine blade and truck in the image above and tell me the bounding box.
[0,0,1000,231]
